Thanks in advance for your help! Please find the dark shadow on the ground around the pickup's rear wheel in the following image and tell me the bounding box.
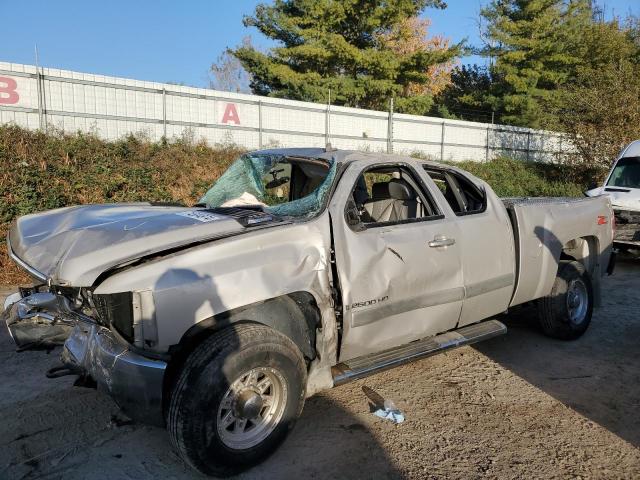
[474,258,640,447]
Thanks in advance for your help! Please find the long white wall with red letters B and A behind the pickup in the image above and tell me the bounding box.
[0,62,569,161]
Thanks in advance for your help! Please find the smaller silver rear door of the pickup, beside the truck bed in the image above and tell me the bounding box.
[424,165,516,327]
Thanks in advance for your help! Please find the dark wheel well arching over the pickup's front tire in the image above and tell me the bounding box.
[163,292,321,418]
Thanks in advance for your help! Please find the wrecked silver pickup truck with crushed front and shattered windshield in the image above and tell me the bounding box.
[4,148,613,475]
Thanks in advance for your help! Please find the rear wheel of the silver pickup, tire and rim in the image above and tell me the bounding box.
[538,260,593,340]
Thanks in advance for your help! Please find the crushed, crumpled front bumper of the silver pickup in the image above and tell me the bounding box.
[4,297,167,426]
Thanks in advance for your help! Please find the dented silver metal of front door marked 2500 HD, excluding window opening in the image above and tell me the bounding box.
[330,154,464,361]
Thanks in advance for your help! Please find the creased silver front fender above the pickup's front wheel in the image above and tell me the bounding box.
[95,212,337,394]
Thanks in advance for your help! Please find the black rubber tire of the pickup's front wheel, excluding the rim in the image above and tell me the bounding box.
[167,324,307,476]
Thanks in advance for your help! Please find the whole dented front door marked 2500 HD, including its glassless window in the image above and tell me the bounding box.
[330,159,464,361]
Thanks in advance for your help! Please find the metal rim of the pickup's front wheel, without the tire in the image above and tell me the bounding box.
[216,367,287,450]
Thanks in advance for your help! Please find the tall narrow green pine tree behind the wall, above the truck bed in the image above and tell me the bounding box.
[481,0,592,128]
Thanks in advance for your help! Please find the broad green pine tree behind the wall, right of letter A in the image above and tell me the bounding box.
[233,0,461,113]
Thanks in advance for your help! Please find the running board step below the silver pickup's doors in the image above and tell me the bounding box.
[331,320,507,386]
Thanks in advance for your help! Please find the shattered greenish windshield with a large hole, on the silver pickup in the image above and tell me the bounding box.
[199,153,336,217]
